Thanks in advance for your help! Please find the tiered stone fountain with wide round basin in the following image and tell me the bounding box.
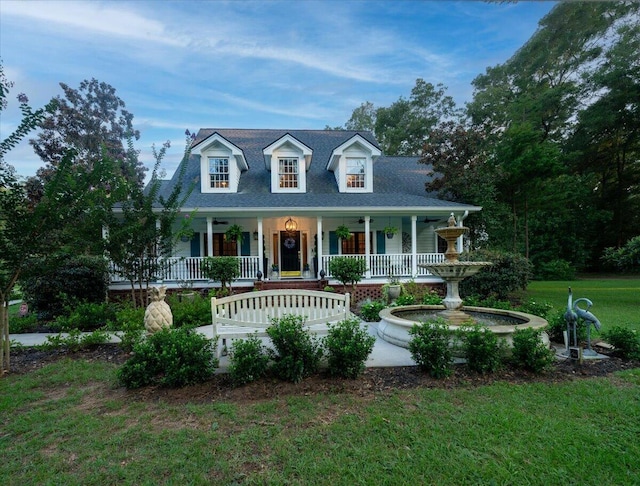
[378,214,549,348]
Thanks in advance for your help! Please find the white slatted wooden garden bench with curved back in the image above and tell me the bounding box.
[211,289,351,357]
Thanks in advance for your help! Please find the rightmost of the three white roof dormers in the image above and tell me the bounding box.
[327,134,382,192]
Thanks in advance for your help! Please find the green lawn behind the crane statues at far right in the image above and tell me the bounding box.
[526,278,640,331]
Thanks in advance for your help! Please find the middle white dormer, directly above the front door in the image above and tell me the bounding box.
[262,133,313,193]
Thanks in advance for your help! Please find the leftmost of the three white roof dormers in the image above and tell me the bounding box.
[191,132,249,193]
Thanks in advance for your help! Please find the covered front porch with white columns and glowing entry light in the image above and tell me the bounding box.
[106,211,467,286]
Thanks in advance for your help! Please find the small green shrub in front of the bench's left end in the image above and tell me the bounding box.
[229,336,269,385]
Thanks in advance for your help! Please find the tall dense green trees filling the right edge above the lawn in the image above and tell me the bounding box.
[467,2,640,264]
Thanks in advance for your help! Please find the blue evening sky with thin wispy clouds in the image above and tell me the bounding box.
[0,0,555,176]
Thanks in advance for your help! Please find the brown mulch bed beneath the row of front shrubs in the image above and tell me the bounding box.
[6,344,640,403]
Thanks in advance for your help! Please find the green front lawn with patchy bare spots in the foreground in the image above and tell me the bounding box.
[0,361,640,485]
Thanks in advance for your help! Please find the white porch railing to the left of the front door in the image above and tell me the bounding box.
[109,256,260,283]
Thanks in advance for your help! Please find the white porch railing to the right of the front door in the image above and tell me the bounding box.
[321,253,444,278]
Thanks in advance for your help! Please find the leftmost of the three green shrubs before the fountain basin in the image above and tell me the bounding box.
[409,318,453,378]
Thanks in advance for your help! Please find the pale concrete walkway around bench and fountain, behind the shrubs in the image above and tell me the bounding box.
[9,322,416,369]
